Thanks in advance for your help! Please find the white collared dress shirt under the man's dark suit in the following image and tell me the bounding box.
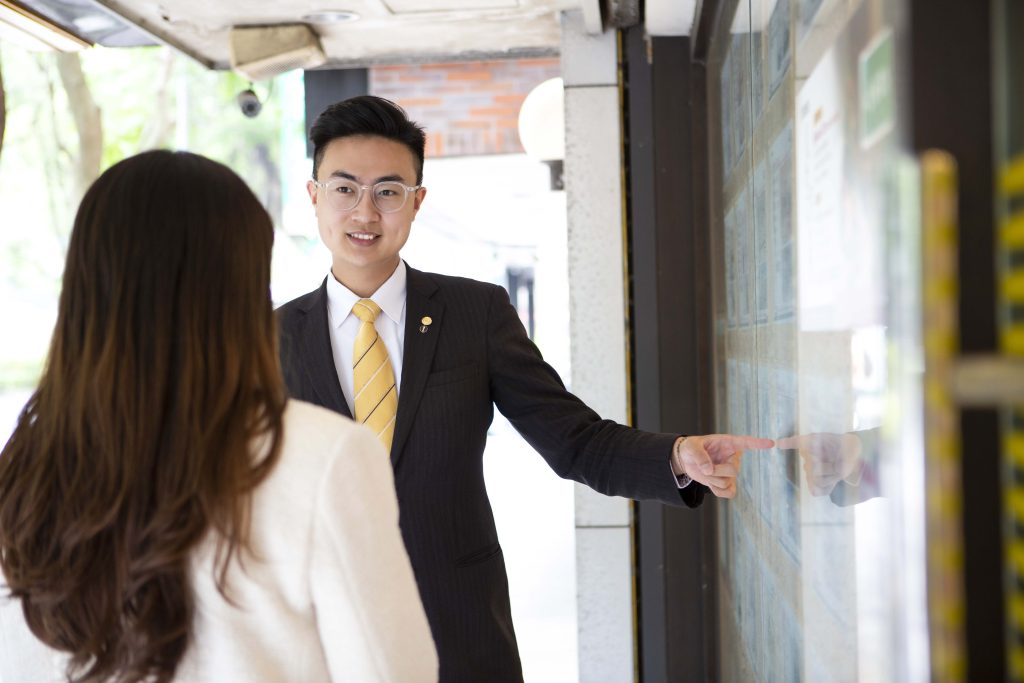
[327,261,406,415]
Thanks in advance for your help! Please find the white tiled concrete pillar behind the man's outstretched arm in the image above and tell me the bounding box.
[561,10,635,683]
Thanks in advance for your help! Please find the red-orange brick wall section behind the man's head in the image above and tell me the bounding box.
[370,57,561,158]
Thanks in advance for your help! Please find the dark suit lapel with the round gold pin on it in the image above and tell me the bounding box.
[391,264,444,466]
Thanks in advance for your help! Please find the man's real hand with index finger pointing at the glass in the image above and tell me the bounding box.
[672,434,775,498]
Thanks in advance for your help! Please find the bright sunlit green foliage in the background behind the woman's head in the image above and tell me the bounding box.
[0,43,302,391]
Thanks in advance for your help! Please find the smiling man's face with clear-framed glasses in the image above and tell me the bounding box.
[306,135,427,295]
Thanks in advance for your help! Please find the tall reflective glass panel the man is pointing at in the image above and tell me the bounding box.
[709,0,928,682]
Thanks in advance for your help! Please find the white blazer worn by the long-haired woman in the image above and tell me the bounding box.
[0,400,437,683]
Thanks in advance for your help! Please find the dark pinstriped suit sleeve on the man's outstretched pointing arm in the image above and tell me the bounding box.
[487,287,708,507]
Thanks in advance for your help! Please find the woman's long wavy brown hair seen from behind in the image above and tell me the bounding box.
[0,152,285,681]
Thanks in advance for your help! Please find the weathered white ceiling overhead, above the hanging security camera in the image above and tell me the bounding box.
[95,0,600,69]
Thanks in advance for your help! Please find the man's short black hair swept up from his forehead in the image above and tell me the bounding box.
[309,95,427,184]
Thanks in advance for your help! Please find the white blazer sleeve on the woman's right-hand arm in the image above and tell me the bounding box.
[310,427,438,683]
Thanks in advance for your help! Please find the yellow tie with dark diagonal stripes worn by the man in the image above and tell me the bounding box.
[352,299,398,452]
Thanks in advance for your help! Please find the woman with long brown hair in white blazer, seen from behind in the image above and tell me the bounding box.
[0,152,437,683]
